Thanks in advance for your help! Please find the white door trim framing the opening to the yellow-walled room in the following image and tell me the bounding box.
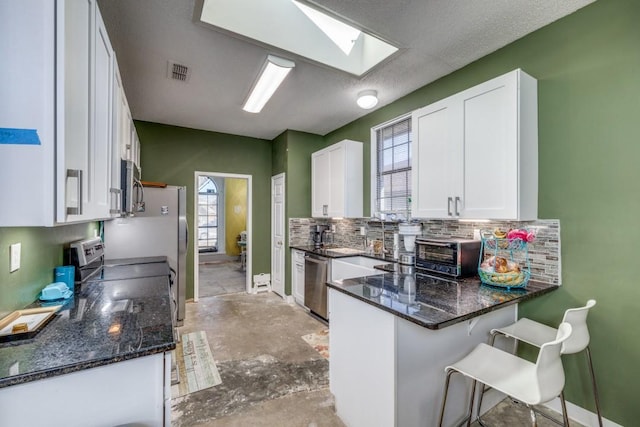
[192,171,253,302]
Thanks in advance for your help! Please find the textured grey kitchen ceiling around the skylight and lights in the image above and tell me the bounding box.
[99,0,594,139]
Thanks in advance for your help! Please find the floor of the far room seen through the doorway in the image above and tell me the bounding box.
[198,257,247,298]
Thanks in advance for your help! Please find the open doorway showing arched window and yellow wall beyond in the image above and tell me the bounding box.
[192,171,252,301]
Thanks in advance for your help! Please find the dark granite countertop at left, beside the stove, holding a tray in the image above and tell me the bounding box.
[0,277,176,388]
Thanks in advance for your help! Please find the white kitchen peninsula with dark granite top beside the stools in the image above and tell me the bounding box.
[328,273,558,427]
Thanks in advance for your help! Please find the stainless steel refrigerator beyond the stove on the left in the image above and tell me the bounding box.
[104,186,188,325]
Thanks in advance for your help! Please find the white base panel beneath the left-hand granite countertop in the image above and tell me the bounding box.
[0,353,171,427]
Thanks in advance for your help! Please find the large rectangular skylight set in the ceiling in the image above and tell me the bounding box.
[196,0,398,76]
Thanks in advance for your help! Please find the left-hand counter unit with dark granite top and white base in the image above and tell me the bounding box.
[0,277,176,426]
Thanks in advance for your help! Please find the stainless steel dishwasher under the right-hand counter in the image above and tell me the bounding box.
[304,253,331,320]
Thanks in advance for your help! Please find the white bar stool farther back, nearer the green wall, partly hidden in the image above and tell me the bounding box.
[488,299,602,427]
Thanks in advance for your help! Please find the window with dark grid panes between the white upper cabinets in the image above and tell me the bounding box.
[372,115,411,219]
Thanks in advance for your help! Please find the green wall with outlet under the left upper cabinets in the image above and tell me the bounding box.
[0,222,98,318]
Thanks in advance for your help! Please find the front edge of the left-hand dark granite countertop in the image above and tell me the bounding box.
[0,342,176,388]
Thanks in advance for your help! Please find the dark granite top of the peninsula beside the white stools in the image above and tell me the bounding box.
[327,269,558,329]
